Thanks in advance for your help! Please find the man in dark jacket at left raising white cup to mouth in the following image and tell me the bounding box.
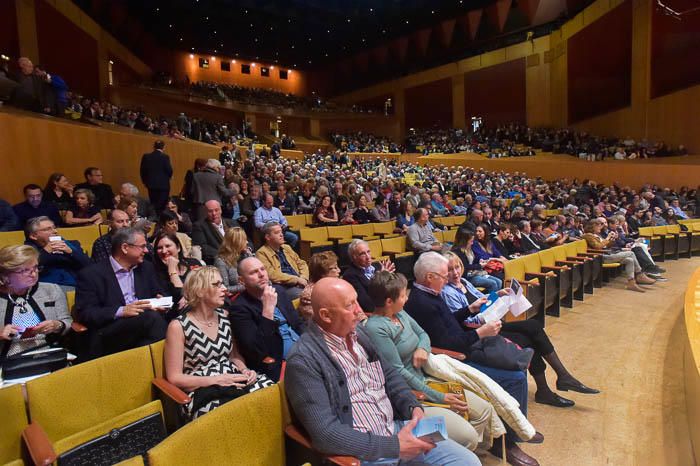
[24,216,90,291]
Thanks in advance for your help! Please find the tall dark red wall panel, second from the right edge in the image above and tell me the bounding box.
[567,0,632,123]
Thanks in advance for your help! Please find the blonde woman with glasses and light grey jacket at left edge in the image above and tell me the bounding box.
[0,246,73,361]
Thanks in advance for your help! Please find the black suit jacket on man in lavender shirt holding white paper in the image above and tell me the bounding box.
[75,260,166,328]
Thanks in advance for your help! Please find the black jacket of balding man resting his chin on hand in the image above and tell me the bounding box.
[229,285,305,381]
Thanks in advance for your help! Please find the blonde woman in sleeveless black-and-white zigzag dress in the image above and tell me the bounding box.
[165,267,273,420]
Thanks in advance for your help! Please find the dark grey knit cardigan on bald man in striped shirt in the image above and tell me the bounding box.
[284,324,420,460]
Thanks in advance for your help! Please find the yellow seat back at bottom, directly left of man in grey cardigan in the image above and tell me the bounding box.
[148,384,286,466]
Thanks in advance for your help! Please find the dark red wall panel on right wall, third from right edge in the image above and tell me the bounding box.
[464,58,527,125]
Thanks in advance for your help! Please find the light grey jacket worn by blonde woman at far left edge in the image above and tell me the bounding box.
[0,283,73,355]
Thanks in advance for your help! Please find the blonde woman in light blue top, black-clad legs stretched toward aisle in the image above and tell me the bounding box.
[440,252,598,408]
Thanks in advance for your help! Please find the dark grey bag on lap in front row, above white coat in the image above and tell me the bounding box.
[469,335,535,371]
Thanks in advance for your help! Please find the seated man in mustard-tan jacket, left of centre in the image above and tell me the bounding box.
[255,221,309,300]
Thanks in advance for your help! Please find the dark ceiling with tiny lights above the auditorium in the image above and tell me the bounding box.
[74,0,504,68]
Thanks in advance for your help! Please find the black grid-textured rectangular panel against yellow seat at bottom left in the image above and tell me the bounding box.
[57,413,165,466]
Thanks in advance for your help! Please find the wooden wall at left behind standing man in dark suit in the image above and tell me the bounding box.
[0,112,219,203]
